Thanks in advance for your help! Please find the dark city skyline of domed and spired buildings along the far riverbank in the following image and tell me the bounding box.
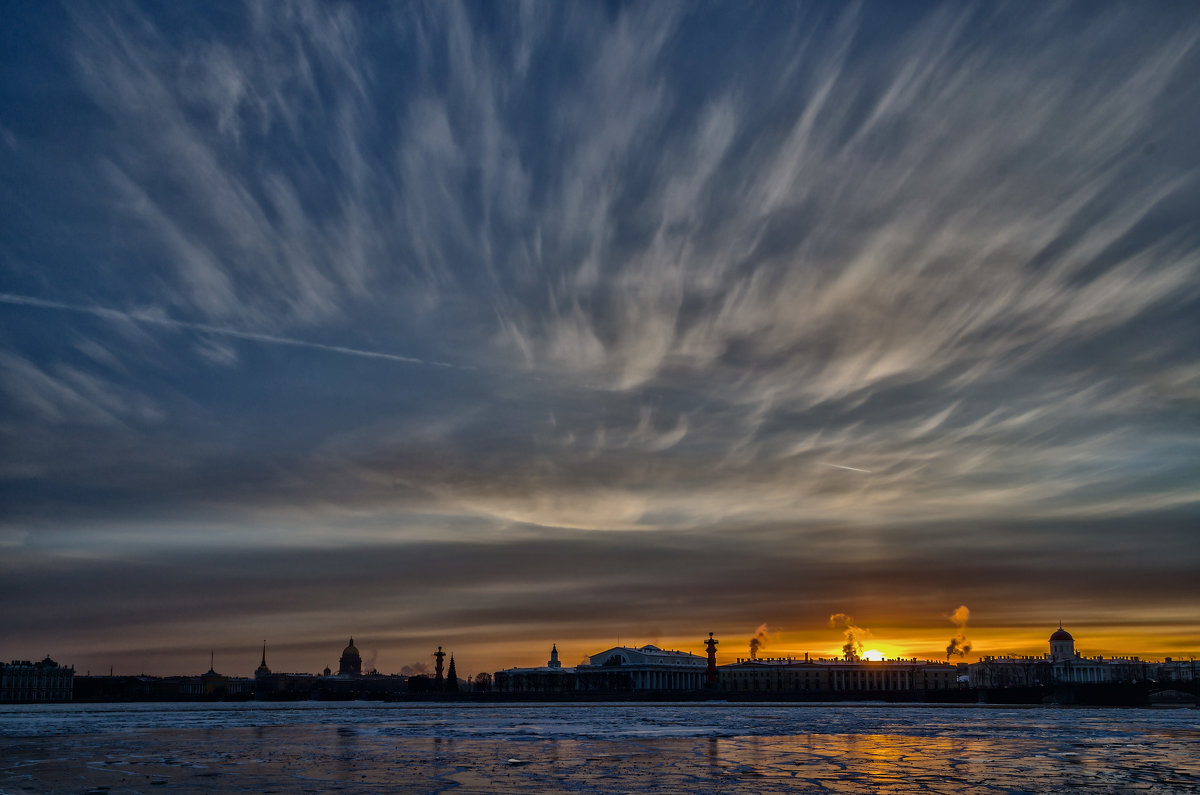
[42,624,1200,704]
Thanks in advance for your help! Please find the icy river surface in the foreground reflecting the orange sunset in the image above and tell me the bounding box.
[0,703,1200,794]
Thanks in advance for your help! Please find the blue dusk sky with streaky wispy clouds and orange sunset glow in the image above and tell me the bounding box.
[0,1,1200,674]
